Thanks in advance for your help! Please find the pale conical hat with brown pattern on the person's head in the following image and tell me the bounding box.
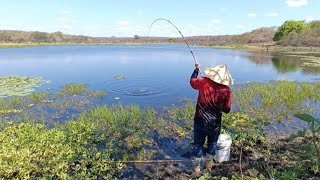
[204,64,233,86]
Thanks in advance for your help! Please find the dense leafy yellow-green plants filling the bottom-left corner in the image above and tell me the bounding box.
[0,121,123,179]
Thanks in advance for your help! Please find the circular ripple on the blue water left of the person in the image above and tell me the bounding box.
[109,79,166,96]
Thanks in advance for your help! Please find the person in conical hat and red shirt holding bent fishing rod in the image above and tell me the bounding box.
[190,63,233,174]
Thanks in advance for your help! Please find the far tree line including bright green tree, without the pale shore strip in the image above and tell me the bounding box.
[0,20,320,47]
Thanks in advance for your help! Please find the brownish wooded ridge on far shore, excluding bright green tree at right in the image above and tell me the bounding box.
[0,27,276,46]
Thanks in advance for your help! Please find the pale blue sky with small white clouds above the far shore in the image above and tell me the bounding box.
[0,0,320,37]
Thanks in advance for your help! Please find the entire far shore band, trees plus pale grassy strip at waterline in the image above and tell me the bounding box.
[0,20,320,52]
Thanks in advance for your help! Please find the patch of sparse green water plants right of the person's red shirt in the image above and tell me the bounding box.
[233,81,320,121]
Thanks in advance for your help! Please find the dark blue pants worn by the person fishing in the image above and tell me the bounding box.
[193,120,221,158]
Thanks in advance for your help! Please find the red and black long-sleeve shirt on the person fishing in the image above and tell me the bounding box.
[190,69,232,124]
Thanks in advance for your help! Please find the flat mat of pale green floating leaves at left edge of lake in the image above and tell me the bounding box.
[0,77,49,98]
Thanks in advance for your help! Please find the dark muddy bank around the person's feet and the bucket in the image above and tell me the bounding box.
[120,136,320,180]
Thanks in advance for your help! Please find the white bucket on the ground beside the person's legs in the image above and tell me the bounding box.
[213,134,232,163]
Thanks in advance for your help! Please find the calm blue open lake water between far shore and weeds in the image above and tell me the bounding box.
[0,45,320,107]
